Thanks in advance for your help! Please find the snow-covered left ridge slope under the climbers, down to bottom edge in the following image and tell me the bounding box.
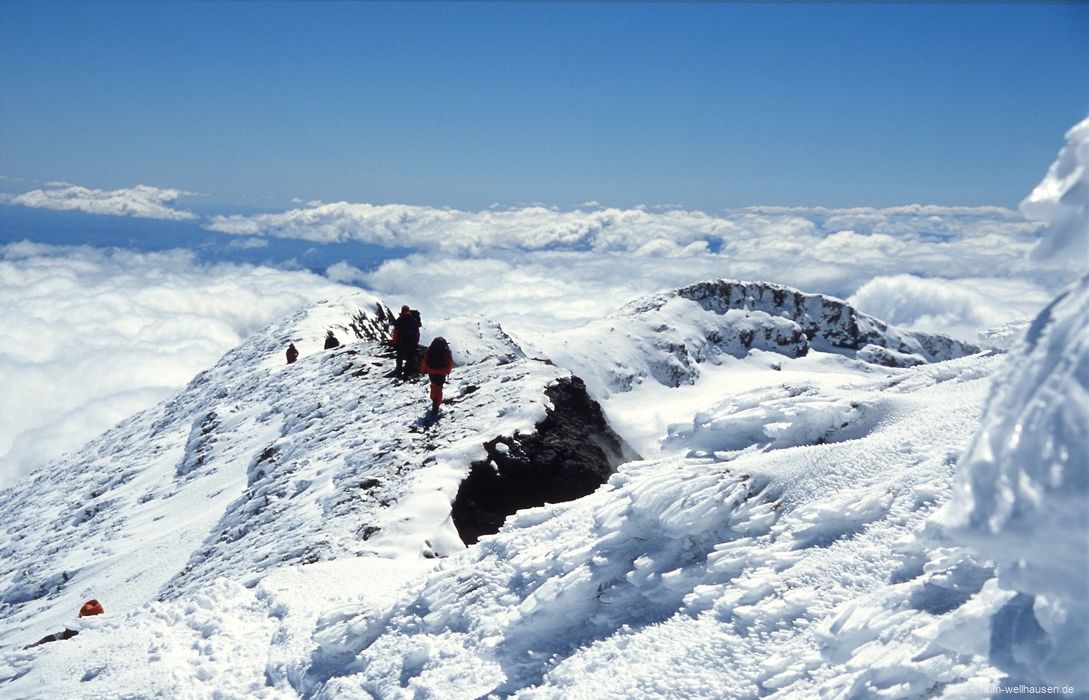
[0,295,565,697]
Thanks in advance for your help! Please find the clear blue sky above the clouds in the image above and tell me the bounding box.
[0,0,1089,211]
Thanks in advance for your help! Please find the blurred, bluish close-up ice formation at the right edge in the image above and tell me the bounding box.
[945,277,1089,690]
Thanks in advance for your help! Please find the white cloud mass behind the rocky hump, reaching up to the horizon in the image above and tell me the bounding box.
[214,202,1084,340]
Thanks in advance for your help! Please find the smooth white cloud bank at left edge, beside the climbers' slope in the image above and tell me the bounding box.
[0,243,357,483]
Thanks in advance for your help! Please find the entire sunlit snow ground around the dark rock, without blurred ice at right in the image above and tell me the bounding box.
[0,280,1036,698]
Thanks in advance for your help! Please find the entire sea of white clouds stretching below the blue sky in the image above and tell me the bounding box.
[0,120,1089,484]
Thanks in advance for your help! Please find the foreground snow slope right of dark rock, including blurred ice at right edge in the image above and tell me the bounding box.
[295,280,1089,698]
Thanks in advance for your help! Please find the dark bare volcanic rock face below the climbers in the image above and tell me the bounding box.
[452,377,638,544]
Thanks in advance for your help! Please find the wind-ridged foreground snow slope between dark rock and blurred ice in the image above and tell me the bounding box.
[297,357,999,698]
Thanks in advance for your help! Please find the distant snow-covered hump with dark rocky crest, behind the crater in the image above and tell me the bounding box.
[541,280,979,395]
